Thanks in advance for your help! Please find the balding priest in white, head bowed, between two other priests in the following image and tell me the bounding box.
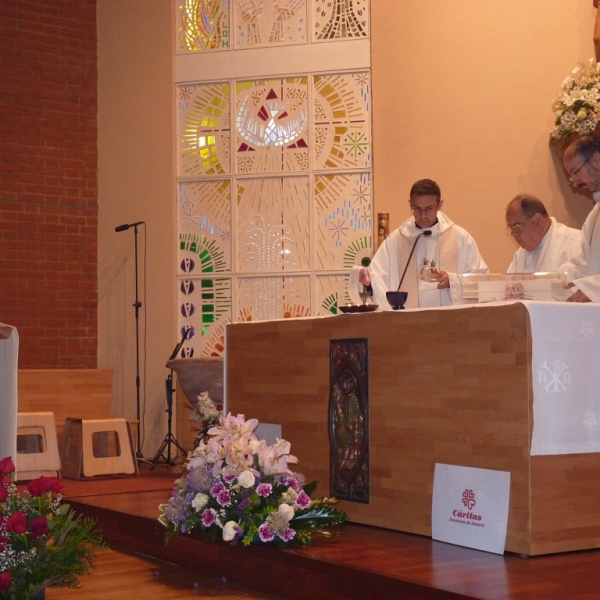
[506,194,582,273]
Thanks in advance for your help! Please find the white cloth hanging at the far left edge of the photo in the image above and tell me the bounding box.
[0,323,19,465]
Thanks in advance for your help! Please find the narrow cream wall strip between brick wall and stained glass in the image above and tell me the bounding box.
[98,0,176,457]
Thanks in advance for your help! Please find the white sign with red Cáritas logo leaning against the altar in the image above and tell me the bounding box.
[431,463,510,554]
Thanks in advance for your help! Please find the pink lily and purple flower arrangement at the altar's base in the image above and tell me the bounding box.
[159,414,348,547]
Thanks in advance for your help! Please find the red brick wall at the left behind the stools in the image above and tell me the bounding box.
[0,0,98,368]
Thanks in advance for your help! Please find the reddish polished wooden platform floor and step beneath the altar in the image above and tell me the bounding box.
[52,466,600,600]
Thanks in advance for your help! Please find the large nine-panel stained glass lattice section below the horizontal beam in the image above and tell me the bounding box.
[178,71,372,356]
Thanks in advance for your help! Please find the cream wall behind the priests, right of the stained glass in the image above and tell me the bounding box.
[371,0,596,272]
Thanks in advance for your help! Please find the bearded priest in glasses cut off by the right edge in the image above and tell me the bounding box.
[561,135,600,302]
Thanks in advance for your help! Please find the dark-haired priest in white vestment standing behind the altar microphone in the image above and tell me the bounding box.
[359,179,489,310]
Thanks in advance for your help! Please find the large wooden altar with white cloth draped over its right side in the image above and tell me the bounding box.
[225,301,600,555]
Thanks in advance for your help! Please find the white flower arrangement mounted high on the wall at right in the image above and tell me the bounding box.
[550,58,600,146]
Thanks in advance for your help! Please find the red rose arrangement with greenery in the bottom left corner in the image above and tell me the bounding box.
[0,457,104,600]
